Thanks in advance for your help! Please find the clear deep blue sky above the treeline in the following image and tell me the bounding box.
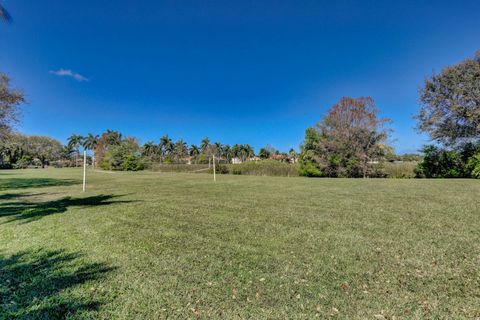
[0,0,480,152]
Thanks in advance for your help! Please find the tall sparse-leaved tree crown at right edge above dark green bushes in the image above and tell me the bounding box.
[417,50,480,146]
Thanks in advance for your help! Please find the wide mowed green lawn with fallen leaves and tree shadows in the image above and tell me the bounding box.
[0,169,480,319]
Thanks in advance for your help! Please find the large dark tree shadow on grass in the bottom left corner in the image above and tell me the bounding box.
[0,250,115,319]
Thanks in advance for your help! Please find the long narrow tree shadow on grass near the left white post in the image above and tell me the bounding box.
[0,194,134,224]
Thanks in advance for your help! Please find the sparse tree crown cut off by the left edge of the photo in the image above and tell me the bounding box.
[0,74,25,139]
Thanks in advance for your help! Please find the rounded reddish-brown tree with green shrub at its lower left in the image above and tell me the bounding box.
[300,97,389,177]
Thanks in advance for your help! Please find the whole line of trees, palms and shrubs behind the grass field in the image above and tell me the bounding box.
[0,52,480,178]
